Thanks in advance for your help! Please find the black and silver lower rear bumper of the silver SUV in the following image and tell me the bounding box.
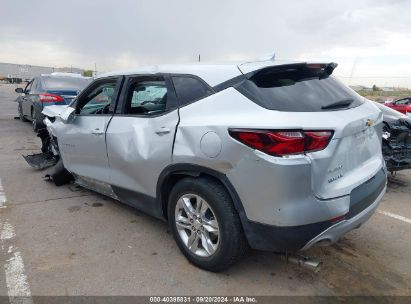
[243,170,387,252]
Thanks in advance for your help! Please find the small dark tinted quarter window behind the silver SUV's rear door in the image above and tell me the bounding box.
[172,76,213,106]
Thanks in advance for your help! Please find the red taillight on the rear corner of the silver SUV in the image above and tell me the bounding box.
[229,129,333,156]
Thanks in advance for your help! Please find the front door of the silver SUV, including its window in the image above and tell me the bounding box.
[58,77,122,183]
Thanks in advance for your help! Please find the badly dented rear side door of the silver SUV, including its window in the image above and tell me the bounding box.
[106,75,179,201]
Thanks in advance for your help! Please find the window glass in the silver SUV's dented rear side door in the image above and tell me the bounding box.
[125,79,167,115]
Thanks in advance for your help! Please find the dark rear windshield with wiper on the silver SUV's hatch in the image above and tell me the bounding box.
[236,65,363,112]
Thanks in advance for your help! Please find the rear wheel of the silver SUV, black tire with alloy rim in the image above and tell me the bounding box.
[168,177,248,272]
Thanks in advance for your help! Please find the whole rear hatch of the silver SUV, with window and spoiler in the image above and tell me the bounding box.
[235,63,383,199]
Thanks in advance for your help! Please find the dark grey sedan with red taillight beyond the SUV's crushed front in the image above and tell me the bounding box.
[15,73,92,131]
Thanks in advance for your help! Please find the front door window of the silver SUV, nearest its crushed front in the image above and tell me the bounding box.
[76,80,117,115]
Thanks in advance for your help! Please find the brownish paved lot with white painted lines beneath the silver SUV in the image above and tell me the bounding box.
[0,85,411,296]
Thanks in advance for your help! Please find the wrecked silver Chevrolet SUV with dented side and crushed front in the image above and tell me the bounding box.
[26,62,386,271]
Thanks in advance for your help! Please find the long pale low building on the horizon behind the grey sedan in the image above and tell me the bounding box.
[0,62,84,81]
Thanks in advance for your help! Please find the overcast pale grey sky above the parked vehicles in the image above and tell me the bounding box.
[0,0,411,88]
